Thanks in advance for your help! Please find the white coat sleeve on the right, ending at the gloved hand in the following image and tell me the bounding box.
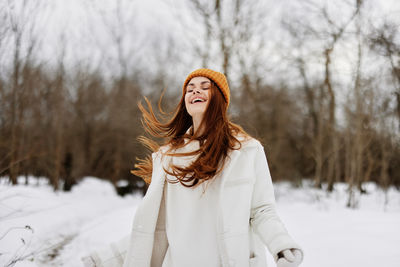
[250,144,303,261]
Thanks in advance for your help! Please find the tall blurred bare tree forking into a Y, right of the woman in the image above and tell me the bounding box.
[284,1,362,190]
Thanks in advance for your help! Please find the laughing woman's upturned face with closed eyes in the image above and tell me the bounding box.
[185,77,211,117]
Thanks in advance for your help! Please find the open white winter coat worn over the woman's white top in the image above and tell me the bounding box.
[85,138,303,267]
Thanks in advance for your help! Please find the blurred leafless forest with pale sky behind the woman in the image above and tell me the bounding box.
[0,0,400,207]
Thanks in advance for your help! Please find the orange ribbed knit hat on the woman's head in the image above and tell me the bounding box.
[183,69,230,107]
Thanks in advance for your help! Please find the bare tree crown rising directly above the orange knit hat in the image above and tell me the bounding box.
[181,0,265,78]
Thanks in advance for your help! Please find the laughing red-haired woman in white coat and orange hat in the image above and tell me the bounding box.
[83,69,303,267]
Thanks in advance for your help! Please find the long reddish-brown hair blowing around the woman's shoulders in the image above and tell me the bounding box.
[131,81,249,187]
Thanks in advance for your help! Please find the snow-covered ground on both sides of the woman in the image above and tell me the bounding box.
[0,177,400,267]
